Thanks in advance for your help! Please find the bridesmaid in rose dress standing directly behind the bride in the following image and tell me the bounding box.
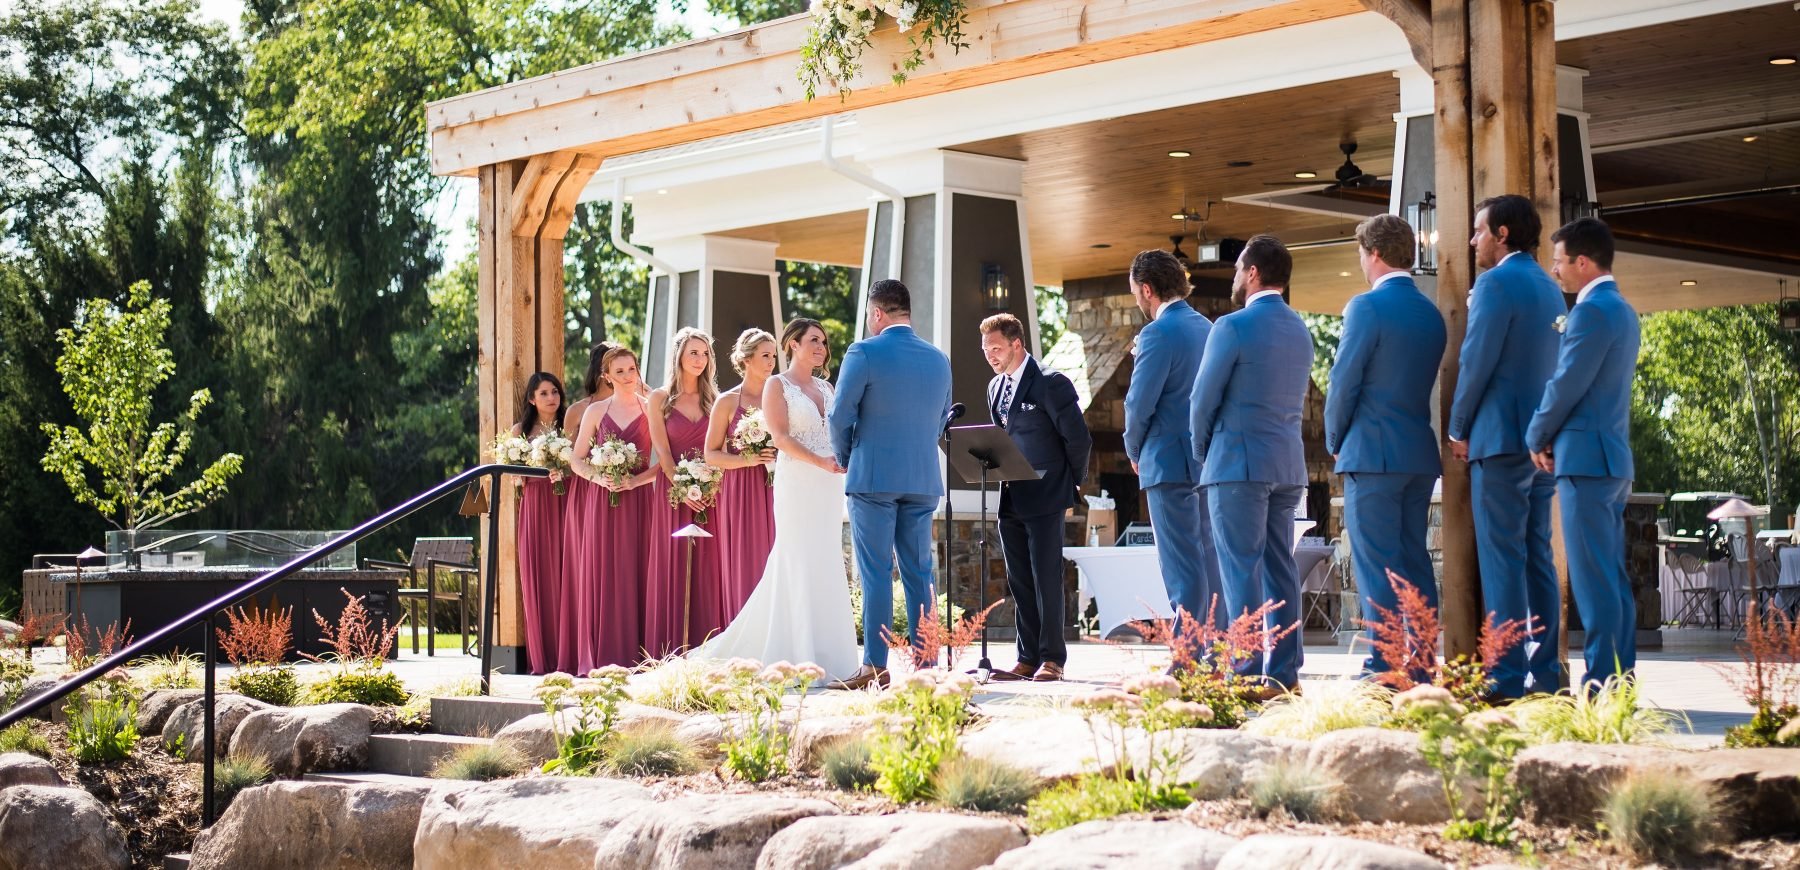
[706,330,776,625]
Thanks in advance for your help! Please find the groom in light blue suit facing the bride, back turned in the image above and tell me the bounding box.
[832,277,950,688]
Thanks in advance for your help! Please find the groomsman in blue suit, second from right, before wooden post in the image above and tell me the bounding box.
[1445,195,1568,699]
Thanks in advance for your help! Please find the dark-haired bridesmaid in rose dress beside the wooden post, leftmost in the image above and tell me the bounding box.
[513,371,569,674]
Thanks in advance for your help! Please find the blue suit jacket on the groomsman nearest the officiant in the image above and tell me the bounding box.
[1125,299,1213,486]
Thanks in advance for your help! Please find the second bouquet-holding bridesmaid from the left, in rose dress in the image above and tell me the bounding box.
[558,346,657,674]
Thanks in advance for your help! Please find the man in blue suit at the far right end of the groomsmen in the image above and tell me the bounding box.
[1525,218,1638,688]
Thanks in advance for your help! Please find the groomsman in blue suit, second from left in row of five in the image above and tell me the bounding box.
[1188,236,1312,701]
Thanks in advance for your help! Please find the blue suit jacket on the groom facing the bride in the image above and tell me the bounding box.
[832,326,950,495]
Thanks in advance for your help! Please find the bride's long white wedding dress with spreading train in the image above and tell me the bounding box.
[691,378,862,677]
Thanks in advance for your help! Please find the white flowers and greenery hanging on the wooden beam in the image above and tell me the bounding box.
[796,0,968,99]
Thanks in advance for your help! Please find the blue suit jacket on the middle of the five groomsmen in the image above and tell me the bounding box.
[1325,276,1445,476]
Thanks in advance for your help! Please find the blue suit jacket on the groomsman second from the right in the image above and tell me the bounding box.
[1447,254,1568,459]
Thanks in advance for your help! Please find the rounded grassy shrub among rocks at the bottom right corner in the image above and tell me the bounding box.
[1600,771,1719,865]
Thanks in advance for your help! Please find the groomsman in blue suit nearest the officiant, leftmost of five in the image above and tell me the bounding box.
[1125,250,1226,644]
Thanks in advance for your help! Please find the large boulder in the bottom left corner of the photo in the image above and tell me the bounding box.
[0,785,131,870]
